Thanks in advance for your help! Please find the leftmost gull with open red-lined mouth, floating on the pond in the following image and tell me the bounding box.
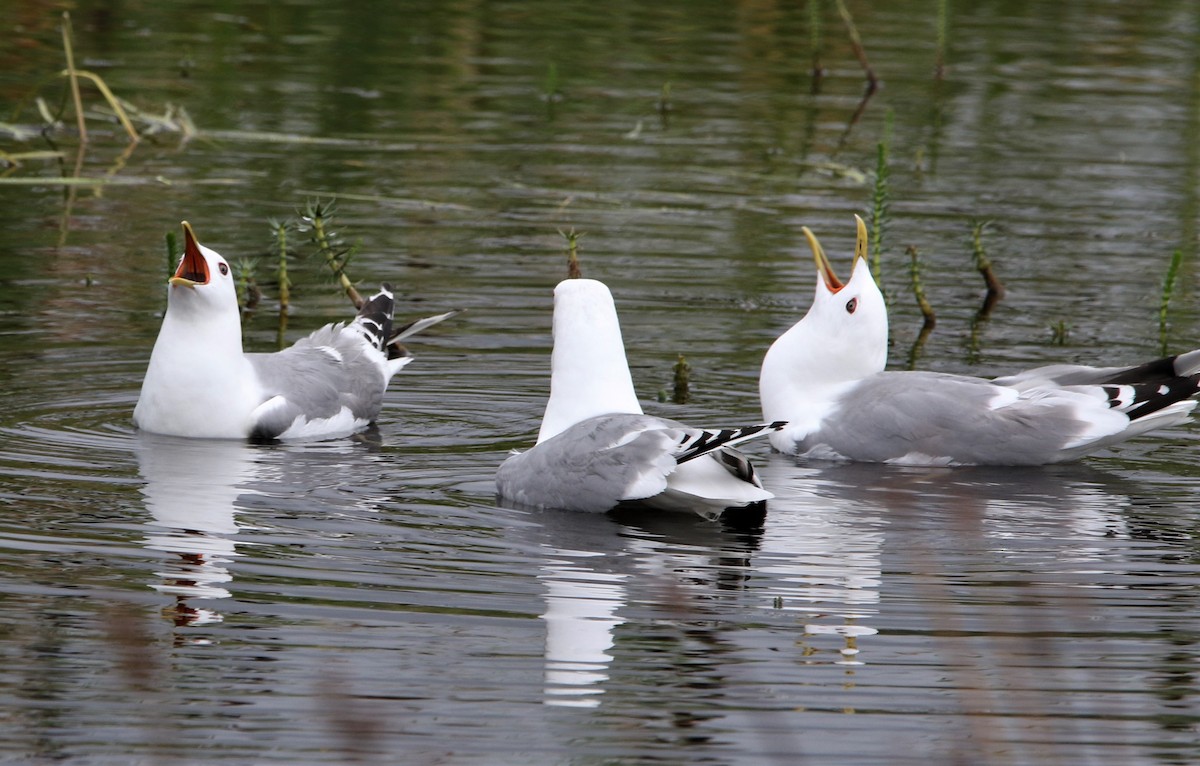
[133,221,457,441]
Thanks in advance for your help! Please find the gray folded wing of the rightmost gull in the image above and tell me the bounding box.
[799,372,1099,465]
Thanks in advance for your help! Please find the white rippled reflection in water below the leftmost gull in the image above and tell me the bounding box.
[136,433,261,626]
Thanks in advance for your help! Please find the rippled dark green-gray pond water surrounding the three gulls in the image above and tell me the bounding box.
[0,0,1200,765]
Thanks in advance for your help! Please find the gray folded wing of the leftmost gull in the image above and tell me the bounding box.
[246,324,388,439]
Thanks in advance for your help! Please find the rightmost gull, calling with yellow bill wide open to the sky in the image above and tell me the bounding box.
[758,216,1200,466]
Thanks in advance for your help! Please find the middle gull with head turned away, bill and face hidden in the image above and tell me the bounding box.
[496,279,784,517]
